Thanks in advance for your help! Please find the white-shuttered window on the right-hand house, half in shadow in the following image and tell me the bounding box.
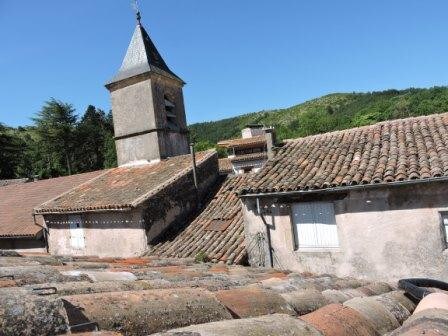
[292,202,339,249]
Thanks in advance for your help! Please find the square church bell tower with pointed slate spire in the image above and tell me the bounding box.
[106,7,189,166]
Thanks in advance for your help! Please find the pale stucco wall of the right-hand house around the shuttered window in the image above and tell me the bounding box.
[243,183,448,280]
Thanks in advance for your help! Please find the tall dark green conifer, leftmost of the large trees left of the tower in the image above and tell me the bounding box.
[33,98,77,176]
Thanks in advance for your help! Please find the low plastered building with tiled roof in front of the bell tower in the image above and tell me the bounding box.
[35,151,218,257]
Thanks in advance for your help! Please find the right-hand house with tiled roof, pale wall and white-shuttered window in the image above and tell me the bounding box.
[241,113,448,279]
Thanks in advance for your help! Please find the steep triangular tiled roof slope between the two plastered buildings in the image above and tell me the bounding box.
[151,175,249,264]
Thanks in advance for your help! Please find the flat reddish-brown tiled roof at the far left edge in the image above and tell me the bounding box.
[0,171,104,237]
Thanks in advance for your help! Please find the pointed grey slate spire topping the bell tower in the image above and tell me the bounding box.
[106,5,185,87]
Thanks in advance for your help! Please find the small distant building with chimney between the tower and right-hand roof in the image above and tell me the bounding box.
[218,125,275,174]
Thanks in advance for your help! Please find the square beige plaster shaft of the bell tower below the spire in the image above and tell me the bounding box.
[111,74,189,165]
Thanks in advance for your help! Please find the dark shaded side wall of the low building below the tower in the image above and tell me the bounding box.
[143,155,218,242]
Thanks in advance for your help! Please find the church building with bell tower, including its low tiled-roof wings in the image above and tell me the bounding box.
[0,12,218,257]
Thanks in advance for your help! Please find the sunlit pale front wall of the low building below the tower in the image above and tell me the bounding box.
[45,210,147,258]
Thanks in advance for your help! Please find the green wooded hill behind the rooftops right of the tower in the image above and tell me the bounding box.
[189,87,448,149]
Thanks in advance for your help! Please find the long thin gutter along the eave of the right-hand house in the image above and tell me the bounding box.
[239,176,448,198]
